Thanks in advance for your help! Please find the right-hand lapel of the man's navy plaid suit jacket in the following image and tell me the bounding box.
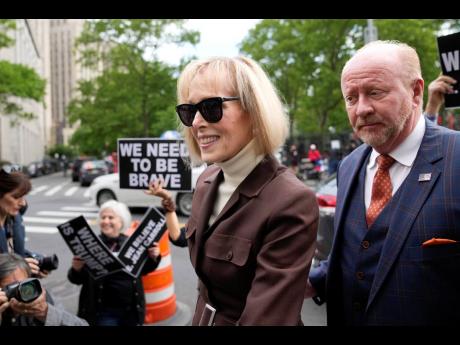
[367,121,443,308]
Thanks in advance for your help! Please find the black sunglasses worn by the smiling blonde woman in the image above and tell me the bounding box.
[176,97,240,127]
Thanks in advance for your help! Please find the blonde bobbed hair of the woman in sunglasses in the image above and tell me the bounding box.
[177,56,289,163]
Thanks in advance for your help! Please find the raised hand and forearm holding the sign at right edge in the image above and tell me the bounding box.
[425,75,457,123]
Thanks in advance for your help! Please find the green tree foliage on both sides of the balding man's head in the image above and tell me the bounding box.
[241,19,460,144]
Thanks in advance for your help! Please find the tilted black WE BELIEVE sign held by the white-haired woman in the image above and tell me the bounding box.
[118,207,166,277]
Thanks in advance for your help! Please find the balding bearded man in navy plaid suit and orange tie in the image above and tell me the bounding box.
[306,41,460,326]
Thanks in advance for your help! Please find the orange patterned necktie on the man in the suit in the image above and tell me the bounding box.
[366,155,395,228]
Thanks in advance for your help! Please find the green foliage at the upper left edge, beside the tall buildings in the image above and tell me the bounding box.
[0,19,46,124]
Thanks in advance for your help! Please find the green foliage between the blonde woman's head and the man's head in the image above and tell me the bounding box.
[241,20,363,141]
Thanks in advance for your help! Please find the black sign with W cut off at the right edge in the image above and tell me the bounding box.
[438,32,460,108]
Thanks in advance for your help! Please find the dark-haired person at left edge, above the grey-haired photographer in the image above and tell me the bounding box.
[0,164,48,278]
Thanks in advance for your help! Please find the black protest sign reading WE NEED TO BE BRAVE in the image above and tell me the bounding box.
[118,138,192,192]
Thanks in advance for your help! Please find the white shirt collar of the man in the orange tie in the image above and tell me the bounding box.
[369,116,426,169]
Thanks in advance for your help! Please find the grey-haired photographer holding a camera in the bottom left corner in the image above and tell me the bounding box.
[0,254,88,326]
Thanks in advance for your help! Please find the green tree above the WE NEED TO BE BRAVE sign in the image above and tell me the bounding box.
[68,19,198,154]
